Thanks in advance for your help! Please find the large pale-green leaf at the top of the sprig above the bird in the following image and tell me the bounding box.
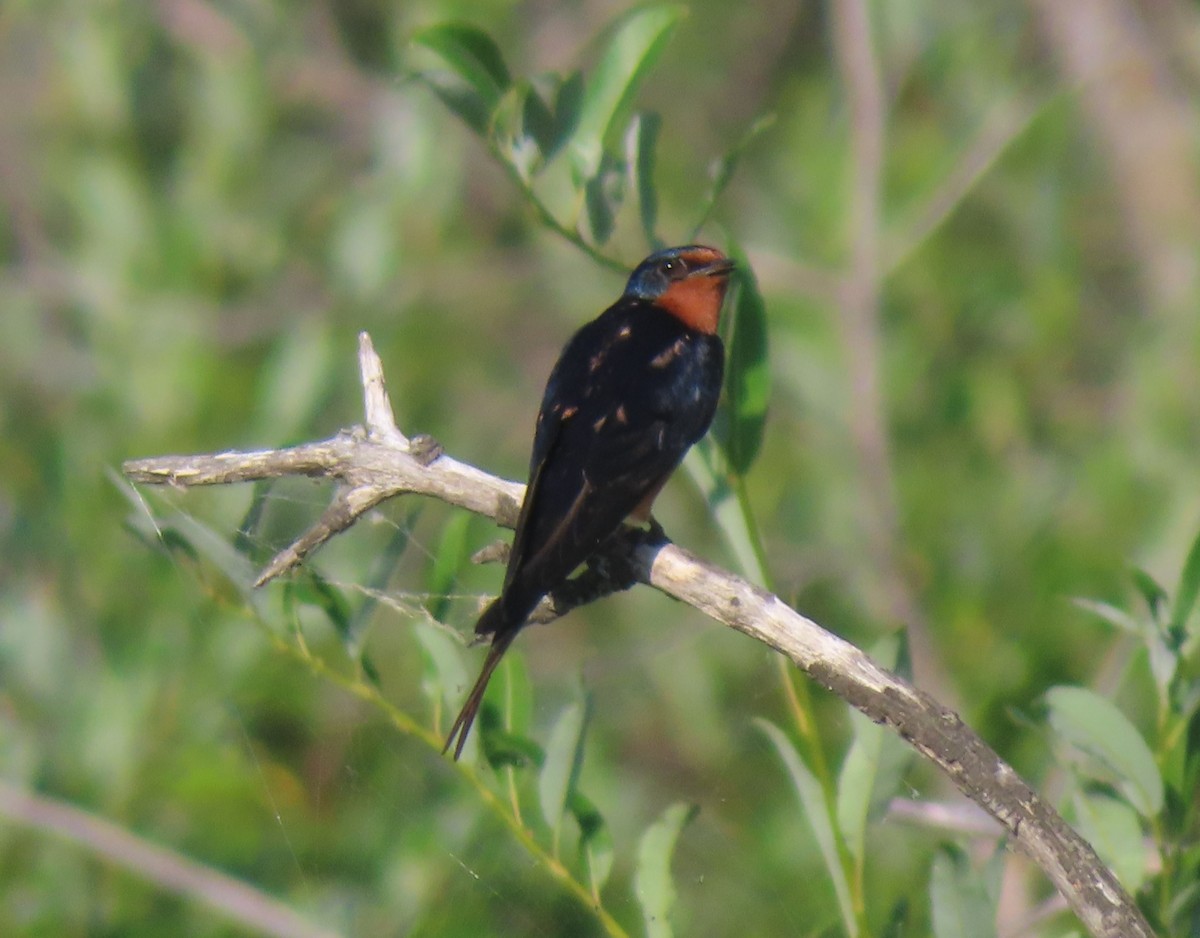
[570,6,686,180]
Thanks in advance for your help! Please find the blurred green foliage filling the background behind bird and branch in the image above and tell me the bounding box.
[7,0,1200,936]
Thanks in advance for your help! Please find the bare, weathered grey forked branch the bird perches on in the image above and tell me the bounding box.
[125,335,1152,938]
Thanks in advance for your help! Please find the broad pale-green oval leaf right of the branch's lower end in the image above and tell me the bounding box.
[1046,687,1163,818]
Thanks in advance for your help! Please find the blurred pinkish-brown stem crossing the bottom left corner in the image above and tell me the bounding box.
[0,780,337,938]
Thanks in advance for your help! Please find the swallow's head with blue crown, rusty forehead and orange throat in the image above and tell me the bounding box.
[625,245,733,335]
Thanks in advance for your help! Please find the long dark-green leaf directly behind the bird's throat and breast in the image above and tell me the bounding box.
[724,254,770,475]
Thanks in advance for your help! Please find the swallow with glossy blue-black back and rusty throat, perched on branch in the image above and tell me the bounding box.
[443,245,733,759]
